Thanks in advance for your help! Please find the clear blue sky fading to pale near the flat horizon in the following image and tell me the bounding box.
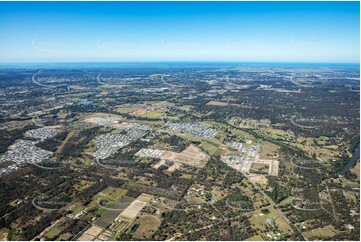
[0,2,360,63]
